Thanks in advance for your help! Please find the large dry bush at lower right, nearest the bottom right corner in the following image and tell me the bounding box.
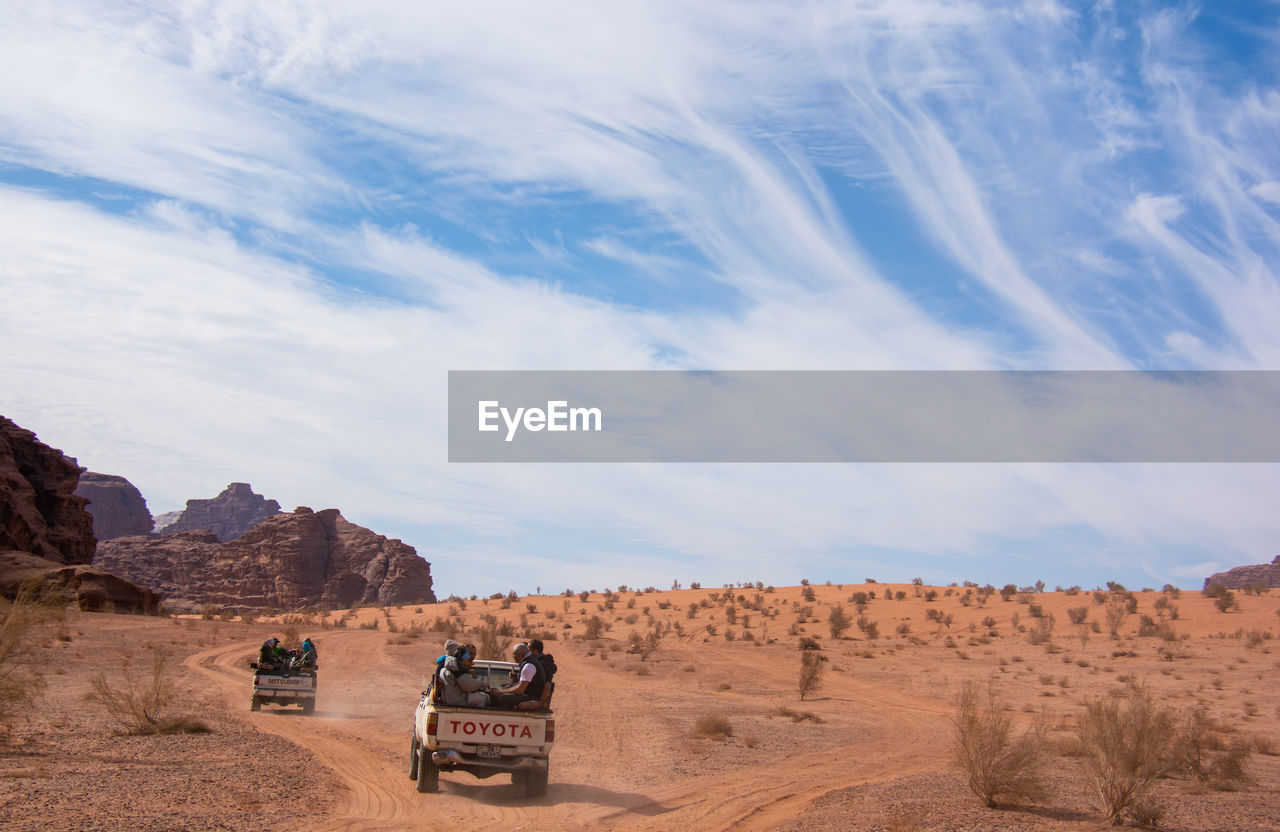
[1078,687,1174,826]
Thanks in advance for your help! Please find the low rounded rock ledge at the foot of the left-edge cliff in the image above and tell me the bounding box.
[0,552,160,613]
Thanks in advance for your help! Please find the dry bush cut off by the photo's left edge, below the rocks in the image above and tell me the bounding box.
[0,584,63,731]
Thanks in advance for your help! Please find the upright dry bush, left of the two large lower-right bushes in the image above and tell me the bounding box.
[954,682,1044,808]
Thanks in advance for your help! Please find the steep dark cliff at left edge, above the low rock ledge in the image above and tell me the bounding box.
[0,416,93,563]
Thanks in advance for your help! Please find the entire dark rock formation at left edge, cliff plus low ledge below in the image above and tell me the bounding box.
[0,416,159,612]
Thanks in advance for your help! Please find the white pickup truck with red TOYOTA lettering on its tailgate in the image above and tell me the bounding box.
[408,660,556,797]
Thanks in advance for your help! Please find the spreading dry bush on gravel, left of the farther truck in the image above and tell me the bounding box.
[86,650,209,735]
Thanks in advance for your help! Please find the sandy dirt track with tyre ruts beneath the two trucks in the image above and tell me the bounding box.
[187,630,947,832]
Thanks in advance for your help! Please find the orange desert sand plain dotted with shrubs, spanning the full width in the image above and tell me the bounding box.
[0,584,1280,831]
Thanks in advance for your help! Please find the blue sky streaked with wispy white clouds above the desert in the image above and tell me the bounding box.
[0,0,1280,595]
